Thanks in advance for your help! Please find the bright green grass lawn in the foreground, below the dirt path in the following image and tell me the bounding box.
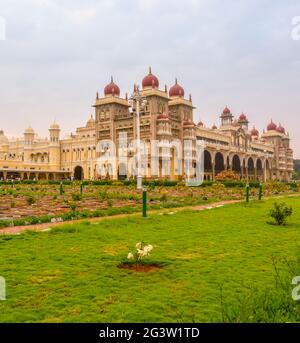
[0,197,300,322]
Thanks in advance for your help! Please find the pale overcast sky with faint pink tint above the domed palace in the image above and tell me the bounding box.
[0,0,300,158]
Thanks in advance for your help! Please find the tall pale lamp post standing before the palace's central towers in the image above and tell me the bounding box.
[129,86,147,189]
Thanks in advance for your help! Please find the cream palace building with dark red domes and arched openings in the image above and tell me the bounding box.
[0,69,293,181]
